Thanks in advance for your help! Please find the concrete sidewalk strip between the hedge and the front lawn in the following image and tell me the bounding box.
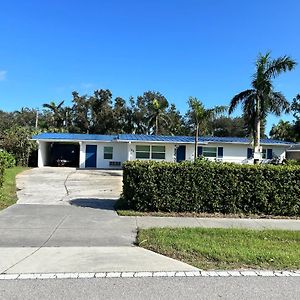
[120,216,300,230]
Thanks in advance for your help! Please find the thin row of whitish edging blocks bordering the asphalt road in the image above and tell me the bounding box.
[0,270,300,280]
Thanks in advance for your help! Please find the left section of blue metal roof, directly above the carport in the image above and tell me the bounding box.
[32,132,118,142]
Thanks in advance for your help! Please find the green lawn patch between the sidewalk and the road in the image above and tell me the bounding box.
[137,228,300,270]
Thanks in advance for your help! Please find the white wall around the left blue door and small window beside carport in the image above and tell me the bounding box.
[79,141,128,169]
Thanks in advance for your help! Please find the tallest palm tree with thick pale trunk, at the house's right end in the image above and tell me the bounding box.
[229,52,296,162]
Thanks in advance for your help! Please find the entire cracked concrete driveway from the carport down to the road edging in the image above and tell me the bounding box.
[0,168,196,274]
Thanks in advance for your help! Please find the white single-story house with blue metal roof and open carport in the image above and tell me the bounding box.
[32,133,293,169]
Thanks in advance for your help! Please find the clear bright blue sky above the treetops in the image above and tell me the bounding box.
[0,0,300,131]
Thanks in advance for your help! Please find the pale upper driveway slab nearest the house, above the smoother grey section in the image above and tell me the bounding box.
[17,167,123,205]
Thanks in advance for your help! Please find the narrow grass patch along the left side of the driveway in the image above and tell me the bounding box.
[0,167,29,210]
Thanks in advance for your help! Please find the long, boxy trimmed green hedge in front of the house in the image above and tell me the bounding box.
[122,161,300,216]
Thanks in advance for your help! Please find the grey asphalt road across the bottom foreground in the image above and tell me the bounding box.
[0,277,300,300]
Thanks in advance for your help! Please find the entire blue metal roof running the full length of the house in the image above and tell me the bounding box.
[32,133,295,145]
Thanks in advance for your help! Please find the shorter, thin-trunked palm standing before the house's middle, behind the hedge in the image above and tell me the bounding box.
[188,97,227,161]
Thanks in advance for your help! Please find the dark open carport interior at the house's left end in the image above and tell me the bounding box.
[44,142,80,168]
